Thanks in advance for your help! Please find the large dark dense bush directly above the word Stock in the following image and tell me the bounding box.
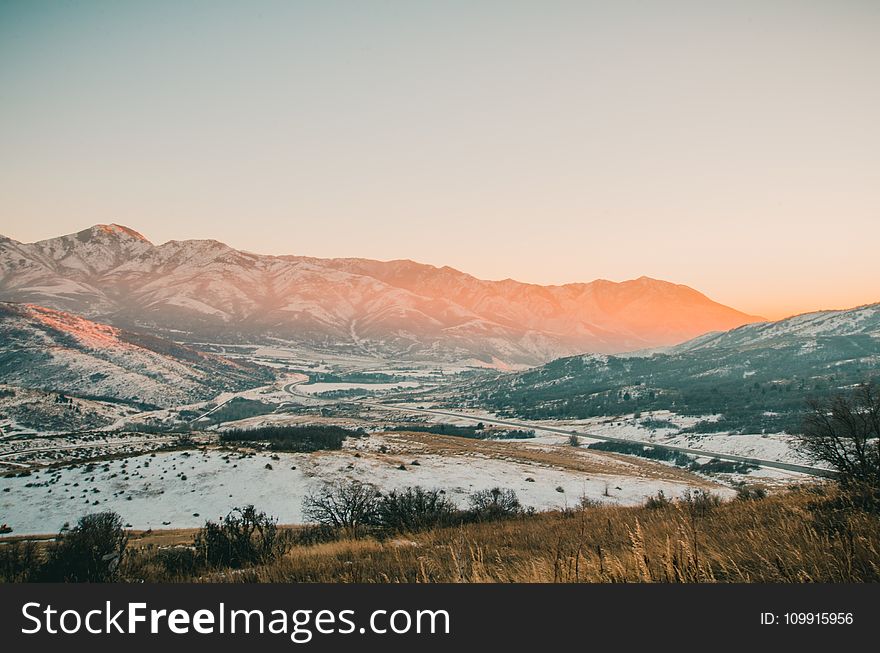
[42,512,128,583]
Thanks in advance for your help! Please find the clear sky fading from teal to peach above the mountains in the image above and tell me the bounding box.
[0,0,880,318]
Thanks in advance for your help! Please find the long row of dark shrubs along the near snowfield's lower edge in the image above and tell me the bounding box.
[0,481,527,583]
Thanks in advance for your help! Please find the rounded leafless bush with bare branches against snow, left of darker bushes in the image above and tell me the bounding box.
[303,481,379,537]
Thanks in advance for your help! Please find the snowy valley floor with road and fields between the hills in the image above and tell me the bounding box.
[0,336,821,536]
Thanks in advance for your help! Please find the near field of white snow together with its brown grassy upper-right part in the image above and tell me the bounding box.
[0,432,733,534]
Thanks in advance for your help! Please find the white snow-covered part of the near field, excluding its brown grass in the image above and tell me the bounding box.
[0,438,720,534]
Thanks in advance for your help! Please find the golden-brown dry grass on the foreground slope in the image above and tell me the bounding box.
[129,487,880,583]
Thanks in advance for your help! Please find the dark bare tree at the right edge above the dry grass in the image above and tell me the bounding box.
[798,383,880,489]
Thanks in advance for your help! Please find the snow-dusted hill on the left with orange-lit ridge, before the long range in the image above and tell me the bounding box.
[0,303,272,406]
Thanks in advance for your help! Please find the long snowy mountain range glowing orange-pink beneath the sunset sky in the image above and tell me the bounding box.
[0,225,760,364]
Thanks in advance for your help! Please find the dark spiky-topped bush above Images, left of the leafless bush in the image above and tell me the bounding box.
[193,505,289,568]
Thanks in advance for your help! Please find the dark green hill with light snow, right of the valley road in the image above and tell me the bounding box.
[462,304,880,433]
